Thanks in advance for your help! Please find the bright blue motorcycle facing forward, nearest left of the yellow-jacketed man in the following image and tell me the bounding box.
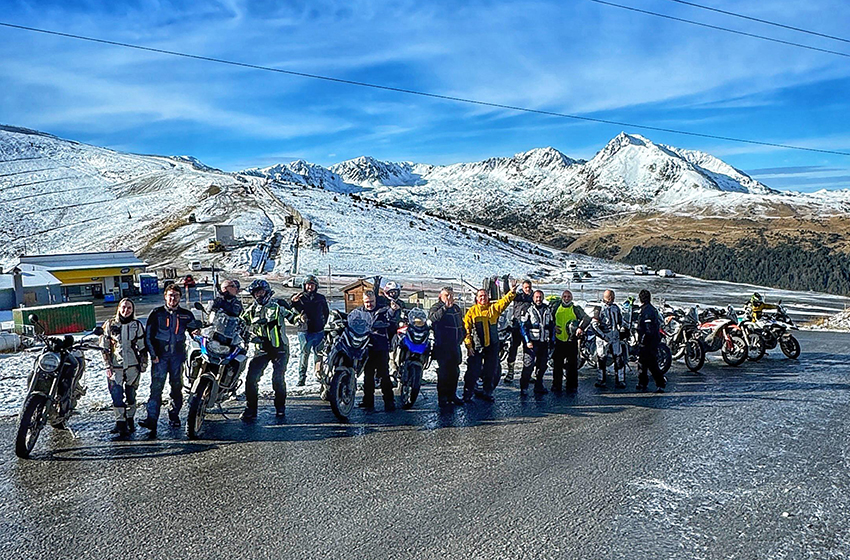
[393,307,431,408]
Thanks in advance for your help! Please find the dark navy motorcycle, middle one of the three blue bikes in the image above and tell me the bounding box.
[316,310,371,422]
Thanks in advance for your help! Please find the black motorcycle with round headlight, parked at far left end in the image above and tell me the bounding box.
[15,314,104,459]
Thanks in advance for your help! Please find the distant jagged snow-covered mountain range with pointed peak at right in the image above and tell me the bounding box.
[240,133,850,227]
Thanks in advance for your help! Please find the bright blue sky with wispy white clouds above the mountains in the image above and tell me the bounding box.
[0,0,850,191]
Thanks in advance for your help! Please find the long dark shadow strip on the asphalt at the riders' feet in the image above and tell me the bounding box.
[19,352,850,461]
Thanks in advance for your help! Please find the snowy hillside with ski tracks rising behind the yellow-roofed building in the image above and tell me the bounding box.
[0,122,562,280]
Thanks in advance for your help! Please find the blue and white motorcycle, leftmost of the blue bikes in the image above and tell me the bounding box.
[186,303,248,439]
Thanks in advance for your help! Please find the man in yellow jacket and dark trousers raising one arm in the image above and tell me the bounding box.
[463,280,517,402]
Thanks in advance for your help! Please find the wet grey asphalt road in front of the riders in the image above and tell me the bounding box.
[0,333,850,560]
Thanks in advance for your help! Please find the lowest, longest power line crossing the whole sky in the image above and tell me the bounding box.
[0,20,850,156]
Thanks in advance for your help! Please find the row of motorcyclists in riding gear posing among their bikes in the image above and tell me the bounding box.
[94,275,773,437]
